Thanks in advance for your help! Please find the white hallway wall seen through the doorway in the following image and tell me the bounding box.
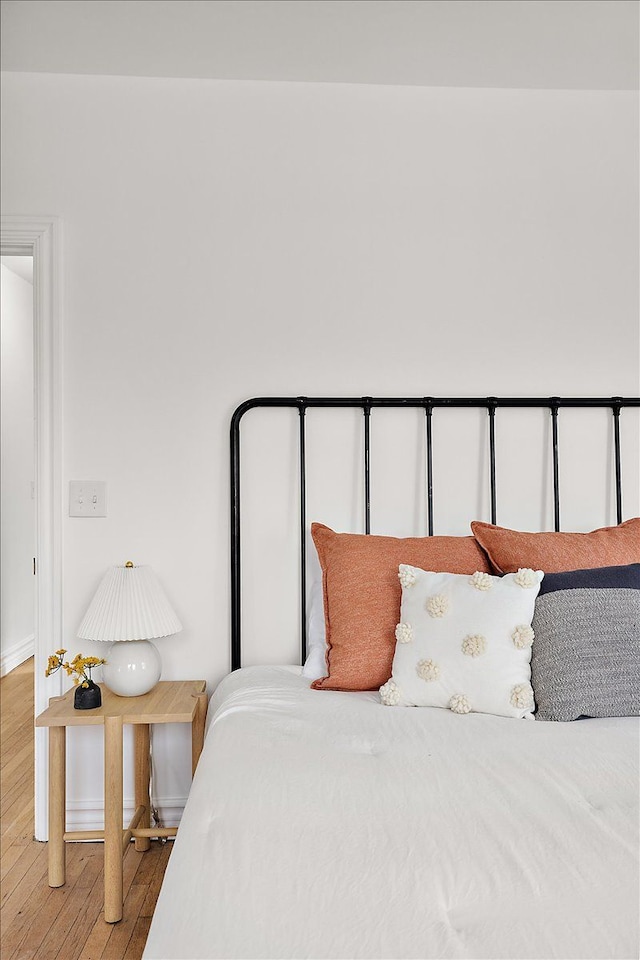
[0,264,35,676]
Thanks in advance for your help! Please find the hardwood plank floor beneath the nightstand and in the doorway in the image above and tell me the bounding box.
[0,660,172,960]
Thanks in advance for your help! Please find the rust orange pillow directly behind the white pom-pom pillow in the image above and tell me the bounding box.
[311,523,490,690]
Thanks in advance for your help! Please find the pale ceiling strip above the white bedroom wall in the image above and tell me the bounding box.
[2,0,639,90]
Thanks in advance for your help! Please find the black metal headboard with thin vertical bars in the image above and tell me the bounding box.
[231,397,640,670]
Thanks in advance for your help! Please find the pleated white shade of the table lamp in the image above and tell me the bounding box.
[78,566,182,640]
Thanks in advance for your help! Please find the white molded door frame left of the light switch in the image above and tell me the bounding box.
[0,215,63,840]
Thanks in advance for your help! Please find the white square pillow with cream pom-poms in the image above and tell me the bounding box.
[380,564,544,717]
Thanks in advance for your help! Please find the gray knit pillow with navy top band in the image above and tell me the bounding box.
[531,563,640,720]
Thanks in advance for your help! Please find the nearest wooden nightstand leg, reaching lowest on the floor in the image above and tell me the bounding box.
[104,717,123,923]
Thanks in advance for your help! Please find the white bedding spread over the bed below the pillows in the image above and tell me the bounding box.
[144,667,639,960]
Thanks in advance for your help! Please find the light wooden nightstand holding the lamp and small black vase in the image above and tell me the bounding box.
[36,680,207,923]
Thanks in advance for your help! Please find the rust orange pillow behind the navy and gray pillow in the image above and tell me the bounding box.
[471,517,640,573]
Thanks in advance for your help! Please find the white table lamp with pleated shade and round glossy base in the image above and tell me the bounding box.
[78,561,182,697]
